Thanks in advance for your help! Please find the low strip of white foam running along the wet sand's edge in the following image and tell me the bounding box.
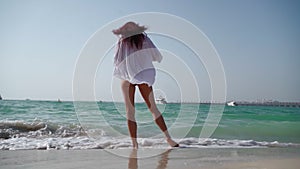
[0,136,300,150]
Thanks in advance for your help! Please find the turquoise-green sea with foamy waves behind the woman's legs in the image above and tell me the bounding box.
[0,100,300,150]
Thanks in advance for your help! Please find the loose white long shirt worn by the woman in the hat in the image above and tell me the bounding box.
[114,35,162,86]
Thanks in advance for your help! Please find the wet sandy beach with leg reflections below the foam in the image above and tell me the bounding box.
[0,148,300,169]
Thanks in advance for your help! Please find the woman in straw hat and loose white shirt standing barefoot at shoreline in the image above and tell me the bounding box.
[113,22,179,148]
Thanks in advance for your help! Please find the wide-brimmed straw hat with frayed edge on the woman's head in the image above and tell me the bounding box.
[112,22,147,37]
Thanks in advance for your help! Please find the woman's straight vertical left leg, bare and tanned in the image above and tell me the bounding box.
[121,81,138,148]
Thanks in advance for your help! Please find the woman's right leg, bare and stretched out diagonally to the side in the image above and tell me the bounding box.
[138,84,178,147]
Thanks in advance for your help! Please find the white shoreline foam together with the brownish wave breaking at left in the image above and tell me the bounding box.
[0,121,300,150]
